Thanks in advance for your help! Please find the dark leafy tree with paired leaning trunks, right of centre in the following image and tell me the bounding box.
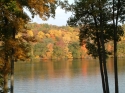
[66,0,123,93]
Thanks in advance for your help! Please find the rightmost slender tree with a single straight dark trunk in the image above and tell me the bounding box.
[111,0,125,93]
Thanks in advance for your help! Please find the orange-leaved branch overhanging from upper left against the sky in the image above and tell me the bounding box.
[22,0,56,20]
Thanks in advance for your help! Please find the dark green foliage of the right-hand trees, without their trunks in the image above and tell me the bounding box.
[65,0,124,57]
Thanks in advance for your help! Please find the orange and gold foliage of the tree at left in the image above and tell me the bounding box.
[0,0,56,93]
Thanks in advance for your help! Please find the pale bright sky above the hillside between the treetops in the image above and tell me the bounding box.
[31,0,74,26]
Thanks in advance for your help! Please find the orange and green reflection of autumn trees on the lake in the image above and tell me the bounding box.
[15,59,125,79]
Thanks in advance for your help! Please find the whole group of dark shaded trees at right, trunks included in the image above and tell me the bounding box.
[65,0,125,93]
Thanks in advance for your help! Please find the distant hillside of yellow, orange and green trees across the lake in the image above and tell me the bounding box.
[16,23,125,59]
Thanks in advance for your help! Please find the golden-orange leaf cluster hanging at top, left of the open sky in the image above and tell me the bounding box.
[28,0,55,20]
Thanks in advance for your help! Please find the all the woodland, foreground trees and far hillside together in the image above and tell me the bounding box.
[0,0,125,93]
